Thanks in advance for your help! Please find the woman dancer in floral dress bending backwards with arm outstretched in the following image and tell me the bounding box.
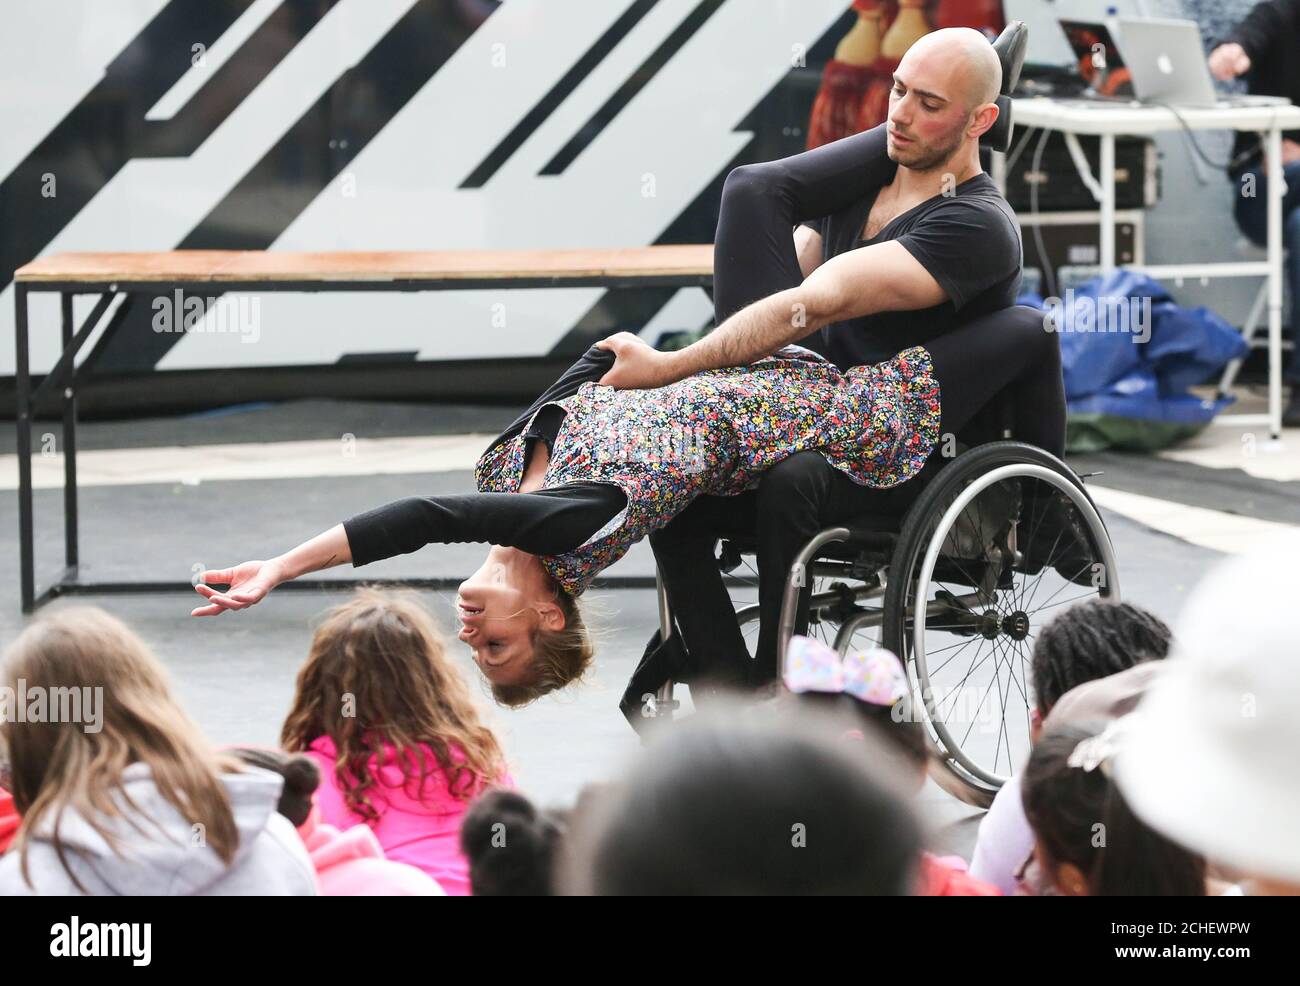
[192,315,1056,706]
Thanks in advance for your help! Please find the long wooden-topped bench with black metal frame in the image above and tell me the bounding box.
[13,243,714,613]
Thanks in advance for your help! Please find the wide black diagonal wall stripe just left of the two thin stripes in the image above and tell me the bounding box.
[86,0,499,372]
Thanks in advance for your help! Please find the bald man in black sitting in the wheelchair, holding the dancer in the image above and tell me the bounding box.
[597,27,1065,691]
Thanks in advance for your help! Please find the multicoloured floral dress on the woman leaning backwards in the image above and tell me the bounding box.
[475,346,940,596]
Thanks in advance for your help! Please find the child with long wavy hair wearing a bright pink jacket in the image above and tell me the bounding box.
[281,589,514,895]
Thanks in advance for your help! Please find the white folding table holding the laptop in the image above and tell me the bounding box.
[993,96,1300,440]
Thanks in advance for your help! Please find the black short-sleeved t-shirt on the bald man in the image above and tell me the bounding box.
[800,172,1023,369]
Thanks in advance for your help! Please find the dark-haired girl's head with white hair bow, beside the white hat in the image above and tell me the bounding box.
[1021,719,1205,896]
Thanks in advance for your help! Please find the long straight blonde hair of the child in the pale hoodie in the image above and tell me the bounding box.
[0,606,239,892]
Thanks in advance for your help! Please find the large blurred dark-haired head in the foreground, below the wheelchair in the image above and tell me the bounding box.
[563,710,922,895]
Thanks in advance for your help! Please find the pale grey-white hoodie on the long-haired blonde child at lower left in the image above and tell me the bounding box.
[0,764,317,896]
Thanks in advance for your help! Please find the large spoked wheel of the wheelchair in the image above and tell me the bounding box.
[883,441,1119,806]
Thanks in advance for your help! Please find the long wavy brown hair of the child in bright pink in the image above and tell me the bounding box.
[280,588,506,821]
